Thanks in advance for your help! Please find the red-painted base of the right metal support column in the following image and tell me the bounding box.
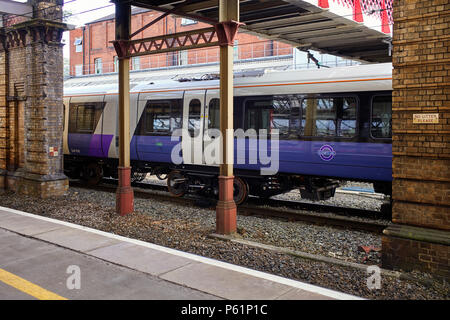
[216,176,237,234]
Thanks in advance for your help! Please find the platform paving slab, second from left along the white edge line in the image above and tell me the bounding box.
[35,227,120,252]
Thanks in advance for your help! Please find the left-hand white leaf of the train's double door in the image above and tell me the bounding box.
[182,90,205,165]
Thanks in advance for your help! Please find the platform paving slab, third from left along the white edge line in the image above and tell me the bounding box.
[88,243,193,276]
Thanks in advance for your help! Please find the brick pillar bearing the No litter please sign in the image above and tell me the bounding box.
[382,0,450,280]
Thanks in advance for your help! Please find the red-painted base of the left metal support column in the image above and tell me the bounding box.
[116,167,134,216]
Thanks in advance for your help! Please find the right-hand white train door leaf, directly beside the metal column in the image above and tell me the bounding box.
[203,90,221,166]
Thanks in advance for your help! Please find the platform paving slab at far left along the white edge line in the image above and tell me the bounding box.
[0,213,63,236]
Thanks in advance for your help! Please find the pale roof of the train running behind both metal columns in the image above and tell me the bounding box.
[64,63,392,96]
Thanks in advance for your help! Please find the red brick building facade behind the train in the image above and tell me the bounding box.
[66,8,292,76]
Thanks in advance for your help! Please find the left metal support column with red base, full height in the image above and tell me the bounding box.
[116,2,134,216]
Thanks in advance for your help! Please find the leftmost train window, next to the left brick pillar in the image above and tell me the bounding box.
[69,102,105,133]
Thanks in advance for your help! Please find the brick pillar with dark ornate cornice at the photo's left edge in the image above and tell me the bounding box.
[0,0,68,198]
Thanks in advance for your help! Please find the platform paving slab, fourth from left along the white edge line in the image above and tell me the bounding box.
[160,263,292,300]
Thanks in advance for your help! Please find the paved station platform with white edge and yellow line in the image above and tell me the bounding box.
[0,207,360,300]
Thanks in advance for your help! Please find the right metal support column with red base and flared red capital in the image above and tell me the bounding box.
[216,0,239,234]
